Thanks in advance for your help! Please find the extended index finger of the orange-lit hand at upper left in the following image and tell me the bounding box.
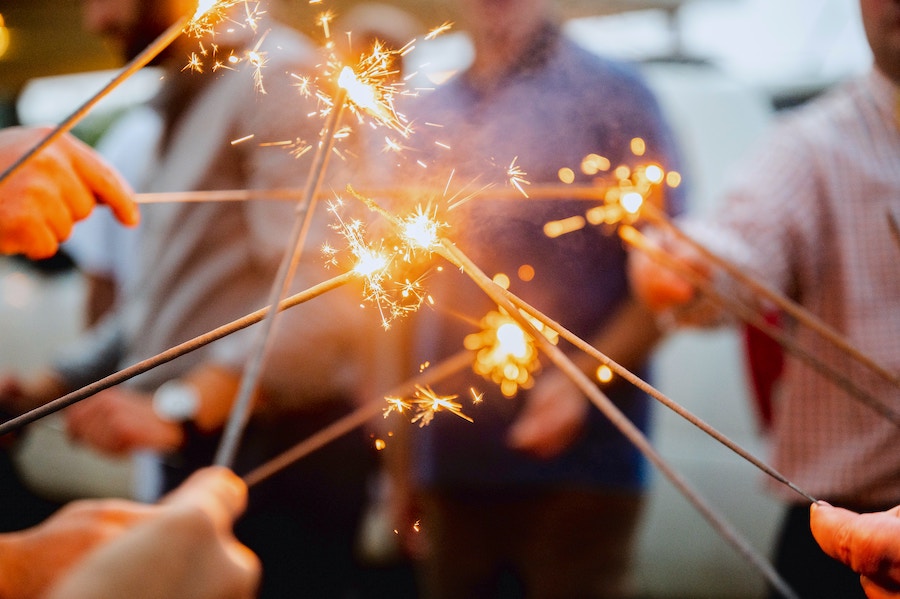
[62,137,140,225]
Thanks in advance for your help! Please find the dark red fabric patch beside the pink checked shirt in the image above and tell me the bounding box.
[744,312,784,430]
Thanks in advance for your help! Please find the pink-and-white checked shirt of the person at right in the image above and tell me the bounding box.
[713,65,900,506]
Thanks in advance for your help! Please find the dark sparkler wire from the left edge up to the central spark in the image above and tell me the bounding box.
[0,271,359,436]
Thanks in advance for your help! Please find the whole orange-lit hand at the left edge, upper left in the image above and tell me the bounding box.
[0,127,139,258]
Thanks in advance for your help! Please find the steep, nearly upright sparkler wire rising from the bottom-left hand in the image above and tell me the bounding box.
[215,87,347,467]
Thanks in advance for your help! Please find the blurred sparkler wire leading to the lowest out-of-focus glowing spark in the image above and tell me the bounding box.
[241,350,472,487]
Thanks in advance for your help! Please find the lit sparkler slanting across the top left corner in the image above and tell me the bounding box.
[0,0,238,188]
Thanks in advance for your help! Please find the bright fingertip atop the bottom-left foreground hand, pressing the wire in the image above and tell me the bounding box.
[162,466,247,530]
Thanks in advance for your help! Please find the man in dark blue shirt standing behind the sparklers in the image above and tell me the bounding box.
[386,0,681,598]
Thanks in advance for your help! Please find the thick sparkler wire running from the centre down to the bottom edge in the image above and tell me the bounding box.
[435,239,799,599]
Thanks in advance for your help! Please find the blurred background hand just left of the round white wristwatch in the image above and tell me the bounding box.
[64,387,184,455]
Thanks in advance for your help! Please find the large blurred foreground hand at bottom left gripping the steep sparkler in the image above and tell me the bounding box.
[45,467,260,599]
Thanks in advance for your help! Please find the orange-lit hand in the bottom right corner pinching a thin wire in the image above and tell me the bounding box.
[810,503,900,599]
